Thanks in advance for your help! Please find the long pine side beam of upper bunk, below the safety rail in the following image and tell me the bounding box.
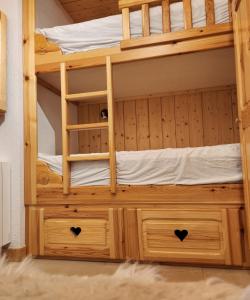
[36,32,234,73]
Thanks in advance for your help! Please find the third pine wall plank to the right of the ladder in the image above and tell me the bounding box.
[136,99,150,150]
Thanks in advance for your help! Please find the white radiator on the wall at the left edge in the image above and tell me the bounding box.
[0,162,11,247]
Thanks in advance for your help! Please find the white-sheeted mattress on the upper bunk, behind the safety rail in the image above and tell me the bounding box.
[37,0,229,54]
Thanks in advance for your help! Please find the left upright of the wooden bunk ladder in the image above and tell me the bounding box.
[61,63,70,194]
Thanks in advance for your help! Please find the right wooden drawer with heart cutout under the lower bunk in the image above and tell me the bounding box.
[137,209,231,264]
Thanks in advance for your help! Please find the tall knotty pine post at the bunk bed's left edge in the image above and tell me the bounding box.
[23,0,37,204]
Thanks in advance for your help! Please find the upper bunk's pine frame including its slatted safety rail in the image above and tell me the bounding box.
[35,0,234,72]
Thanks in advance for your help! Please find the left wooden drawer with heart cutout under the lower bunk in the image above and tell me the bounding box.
[36,207,119,258]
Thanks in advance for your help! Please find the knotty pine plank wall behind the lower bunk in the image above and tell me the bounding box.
[78,86,239,153]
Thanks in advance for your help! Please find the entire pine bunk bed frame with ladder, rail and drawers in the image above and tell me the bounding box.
[24,0,249,266]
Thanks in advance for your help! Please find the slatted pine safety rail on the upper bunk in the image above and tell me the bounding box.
[119,0,232,49]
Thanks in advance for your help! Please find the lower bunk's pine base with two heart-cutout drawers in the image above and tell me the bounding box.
[26,156,246,267]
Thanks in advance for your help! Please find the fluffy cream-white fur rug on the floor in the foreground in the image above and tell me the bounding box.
[0,259,250,300]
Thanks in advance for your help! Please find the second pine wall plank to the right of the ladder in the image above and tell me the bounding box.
[124,101,137,151]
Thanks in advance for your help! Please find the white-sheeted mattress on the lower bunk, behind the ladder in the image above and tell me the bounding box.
[39,144,242,186]
